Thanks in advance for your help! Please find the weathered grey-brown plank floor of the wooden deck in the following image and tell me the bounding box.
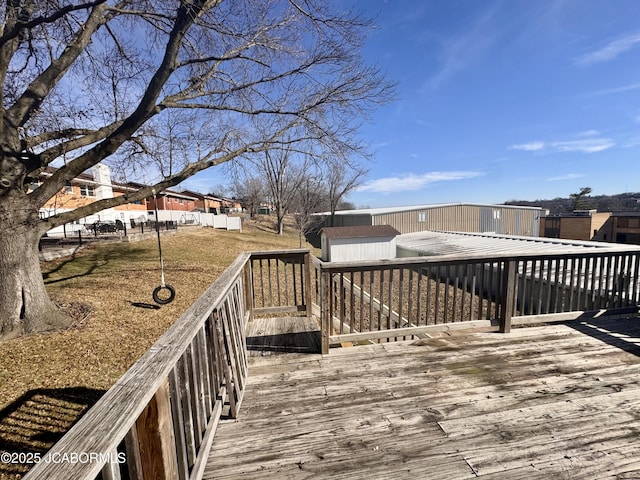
[204,318,640,480]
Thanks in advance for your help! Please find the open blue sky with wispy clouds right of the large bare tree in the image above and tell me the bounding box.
[184,0,640,207]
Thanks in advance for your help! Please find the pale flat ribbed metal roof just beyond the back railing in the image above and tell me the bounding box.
[396,231,640,256]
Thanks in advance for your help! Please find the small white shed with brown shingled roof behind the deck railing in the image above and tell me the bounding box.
[320,225,400,262]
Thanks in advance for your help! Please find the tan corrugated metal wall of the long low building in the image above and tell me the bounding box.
[370,205,541,236]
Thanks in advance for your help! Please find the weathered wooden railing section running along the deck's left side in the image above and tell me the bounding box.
[25,254,250,480]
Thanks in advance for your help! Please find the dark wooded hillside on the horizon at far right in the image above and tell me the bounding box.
[505,192,640,215]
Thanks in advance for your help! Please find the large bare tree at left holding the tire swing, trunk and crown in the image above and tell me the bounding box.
[0,0,393,338]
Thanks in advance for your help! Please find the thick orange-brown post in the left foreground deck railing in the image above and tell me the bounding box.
[136,380,178,480]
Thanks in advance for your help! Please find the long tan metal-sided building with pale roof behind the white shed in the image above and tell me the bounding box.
[316,203,544,236]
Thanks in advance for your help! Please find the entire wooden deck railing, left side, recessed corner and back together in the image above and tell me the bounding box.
[25,250,640,480]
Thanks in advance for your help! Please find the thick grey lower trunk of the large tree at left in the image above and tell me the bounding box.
[0,204,71,340]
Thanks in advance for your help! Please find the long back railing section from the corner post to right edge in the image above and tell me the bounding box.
[313,250,640,353]
